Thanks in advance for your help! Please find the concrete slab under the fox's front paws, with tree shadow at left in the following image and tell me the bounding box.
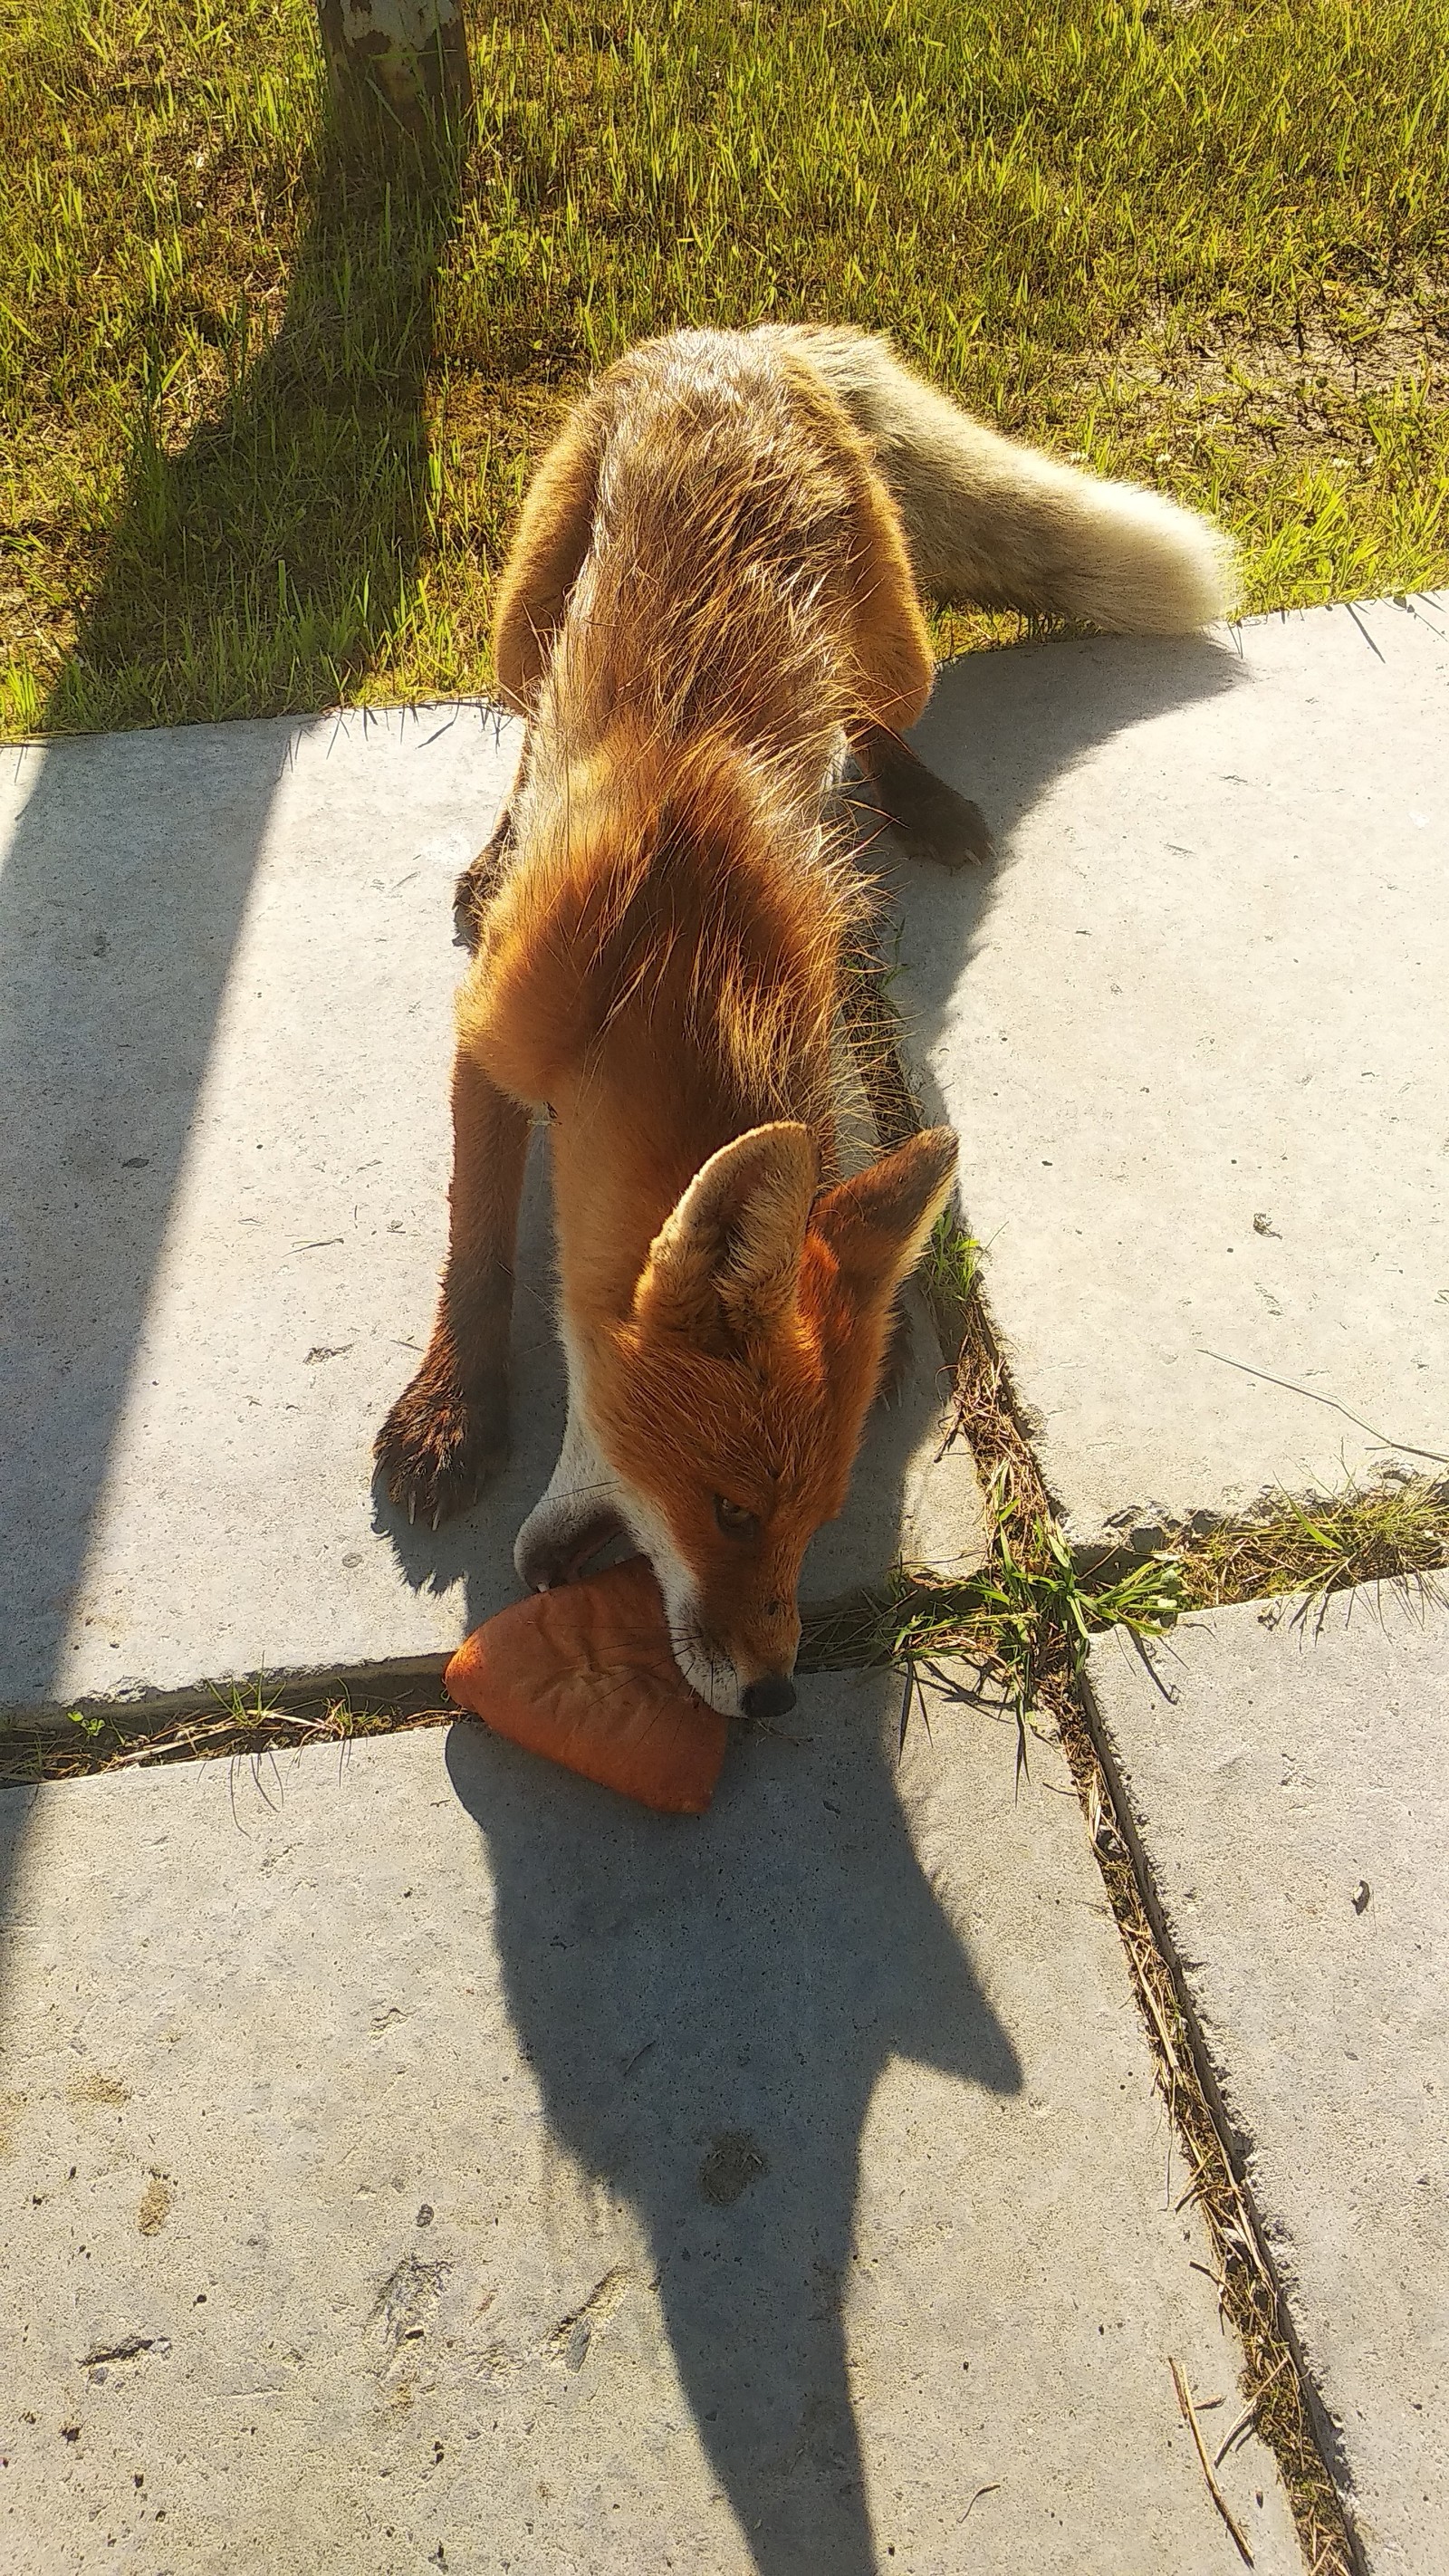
[0,706,981,1710]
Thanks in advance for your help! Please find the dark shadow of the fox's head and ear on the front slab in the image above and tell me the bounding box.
[447,1677,1022,2576]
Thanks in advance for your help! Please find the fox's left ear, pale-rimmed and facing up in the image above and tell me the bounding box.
[633,1118,816,1350]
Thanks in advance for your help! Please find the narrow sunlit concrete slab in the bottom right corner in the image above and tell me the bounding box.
[1091,1587,1449,2576]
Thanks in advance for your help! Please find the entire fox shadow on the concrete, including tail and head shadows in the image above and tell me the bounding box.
[381,639,1241,2576]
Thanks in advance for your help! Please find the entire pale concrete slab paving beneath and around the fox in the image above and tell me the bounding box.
[0,601,1449,2576]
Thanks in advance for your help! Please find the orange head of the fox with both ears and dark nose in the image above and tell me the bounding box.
[561,1120,955,1716]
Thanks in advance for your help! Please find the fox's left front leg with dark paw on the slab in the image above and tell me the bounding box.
[376,1046,533,1527]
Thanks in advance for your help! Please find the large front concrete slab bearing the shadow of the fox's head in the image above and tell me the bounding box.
[0,1675,1300,2576]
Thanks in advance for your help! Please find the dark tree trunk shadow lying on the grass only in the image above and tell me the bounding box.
[46,103,464,732]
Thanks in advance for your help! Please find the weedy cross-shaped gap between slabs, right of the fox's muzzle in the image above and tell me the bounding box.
[833,932,1368,2576]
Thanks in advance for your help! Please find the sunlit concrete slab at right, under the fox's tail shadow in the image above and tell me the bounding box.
[893,595,1449,1543]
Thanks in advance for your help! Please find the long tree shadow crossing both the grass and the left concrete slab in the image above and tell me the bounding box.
[0,105,458,1875]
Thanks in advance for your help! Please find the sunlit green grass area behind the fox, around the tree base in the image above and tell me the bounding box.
[0,0,1449,732]
